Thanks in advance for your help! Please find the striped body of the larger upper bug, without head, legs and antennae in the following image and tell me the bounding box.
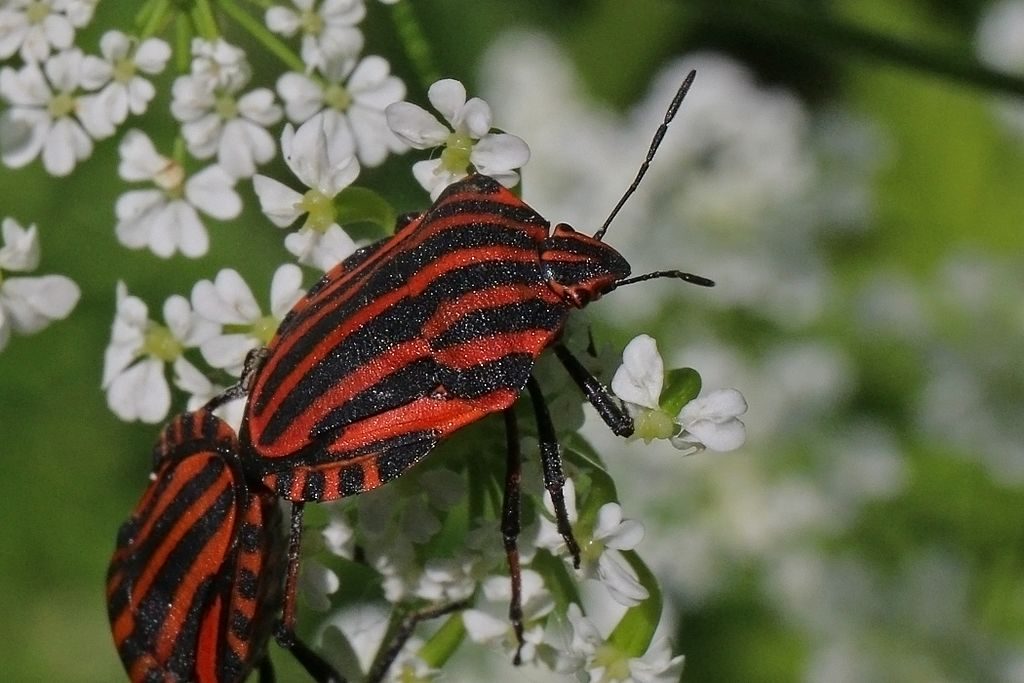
[243,176,568,501]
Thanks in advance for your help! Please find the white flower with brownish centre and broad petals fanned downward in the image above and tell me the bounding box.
[115,130,242,258]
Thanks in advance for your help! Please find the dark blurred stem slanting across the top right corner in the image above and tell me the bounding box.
[701,0,1024,95]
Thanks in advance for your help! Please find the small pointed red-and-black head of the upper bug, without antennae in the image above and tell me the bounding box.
[541,223,630,308]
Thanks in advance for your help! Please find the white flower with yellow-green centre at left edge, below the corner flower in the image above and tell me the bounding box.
[0,48,114,176]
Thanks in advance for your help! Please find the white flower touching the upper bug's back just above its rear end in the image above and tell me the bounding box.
[191,263,303,376]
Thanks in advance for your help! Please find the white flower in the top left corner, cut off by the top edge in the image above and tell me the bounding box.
[0,0,92,62]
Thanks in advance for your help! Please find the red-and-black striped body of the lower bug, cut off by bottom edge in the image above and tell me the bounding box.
[106,411,285,683]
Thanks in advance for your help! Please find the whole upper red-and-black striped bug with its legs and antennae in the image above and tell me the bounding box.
[240,68,713,655]
